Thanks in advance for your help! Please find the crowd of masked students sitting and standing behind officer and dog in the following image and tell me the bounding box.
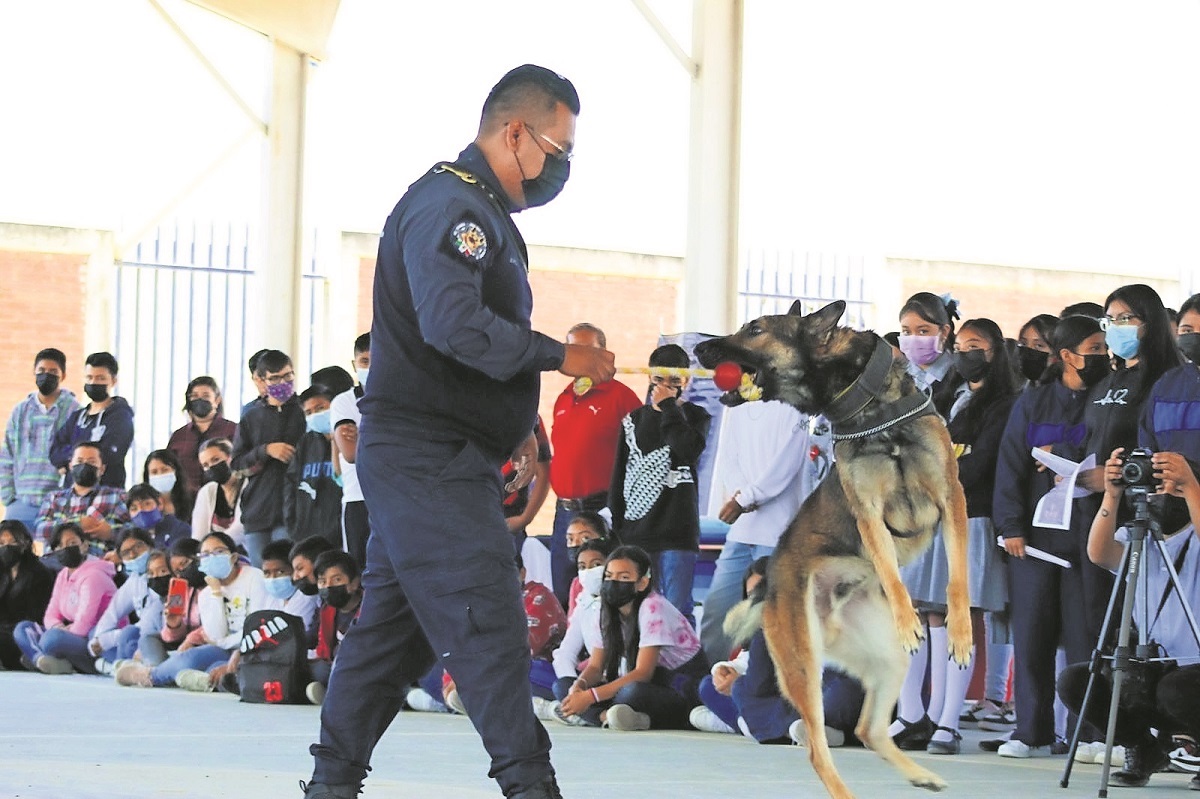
[0,284,1200,789]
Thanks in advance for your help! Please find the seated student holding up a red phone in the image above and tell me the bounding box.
[139,539,206,675]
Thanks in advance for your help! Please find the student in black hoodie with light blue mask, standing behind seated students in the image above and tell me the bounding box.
[283,384,342,547]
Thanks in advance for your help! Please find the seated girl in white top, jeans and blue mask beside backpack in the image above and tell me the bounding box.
[115,533,268,692]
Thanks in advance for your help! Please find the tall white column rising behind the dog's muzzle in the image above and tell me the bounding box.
[682,0,743,334]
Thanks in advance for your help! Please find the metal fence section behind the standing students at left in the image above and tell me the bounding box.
[113,224,328,482]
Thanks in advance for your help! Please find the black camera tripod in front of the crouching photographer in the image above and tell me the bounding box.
[1058,486,1200,799]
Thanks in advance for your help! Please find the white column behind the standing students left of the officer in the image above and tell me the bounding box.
[259,41,308,360]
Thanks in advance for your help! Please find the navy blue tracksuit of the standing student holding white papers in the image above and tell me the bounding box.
[992,380,1096,746]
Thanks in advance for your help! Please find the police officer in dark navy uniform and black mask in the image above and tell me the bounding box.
[305,65,614,799]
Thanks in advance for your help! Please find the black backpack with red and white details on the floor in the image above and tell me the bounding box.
[238,611,308,704]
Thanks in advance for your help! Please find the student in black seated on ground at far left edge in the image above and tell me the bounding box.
[0,519,54,672]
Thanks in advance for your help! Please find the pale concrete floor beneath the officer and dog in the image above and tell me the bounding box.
[0,672,1198,799]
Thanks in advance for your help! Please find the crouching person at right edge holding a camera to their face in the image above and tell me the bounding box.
[1058,449,1200,791]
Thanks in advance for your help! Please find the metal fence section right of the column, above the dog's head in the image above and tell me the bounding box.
[738,250,874,329]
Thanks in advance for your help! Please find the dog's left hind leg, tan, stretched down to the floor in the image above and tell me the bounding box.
[762,576,854,799]
